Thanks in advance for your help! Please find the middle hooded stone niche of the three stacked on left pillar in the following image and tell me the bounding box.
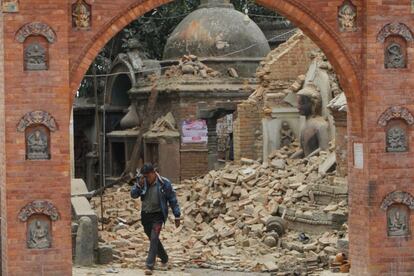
[17,111,57,160]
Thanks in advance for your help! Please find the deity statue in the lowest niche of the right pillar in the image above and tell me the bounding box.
[387,205,409,236]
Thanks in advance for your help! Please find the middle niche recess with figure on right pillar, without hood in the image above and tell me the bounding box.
[386,120,409,152]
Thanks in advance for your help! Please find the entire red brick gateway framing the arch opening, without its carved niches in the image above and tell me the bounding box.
[0,0,414,276]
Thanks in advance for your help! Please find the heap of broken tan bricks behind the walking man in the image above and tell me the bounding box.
[92,144,347,275]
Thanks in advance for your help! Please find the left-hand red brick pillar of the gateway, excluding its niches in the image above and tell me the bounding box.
[0,0,72,276]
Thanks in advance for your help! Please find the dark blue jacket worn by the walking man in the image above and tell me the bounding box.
[131,174,181,223]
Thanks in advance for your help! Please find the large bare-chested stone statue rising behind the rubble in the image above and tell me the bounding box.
[293,83,329,157]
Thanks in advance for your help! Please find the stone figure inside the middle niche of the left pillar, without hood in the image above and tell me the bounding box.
[26,129,49,160]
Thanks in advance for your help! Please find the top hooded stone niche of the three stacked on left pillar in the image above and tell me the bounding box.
[16,22,56,71]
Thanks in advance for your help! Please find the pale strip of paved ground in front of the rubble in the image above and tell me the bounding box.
[73,266,348,276]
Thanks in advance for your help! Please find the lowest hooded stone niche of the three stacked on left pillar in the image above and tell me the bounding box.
[18,200,59,249]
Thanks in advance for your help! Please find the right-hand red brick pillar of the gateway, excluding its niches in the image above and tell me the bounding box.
[350,0,414,275]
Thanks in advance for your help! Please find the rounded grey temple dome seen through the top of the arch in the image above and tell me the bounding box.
[164,0,270,60]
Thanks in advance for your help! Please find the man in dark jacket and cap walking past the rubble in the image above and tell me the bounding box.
[131,163,181,275]
